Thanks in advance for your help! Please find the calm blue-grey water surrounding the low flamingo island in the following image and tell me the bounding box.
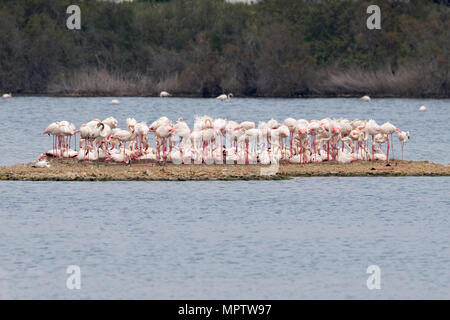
[0,98,450,299]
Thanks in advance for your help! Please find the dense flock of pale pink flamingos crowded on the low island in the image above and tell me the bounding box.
[39,116,410,165]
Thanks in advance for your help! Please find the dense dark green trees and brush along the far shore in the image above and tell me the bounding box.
[0,0,450,97]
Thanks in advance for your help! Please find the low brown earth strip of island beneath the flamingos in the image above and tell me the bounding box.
[0,159,450,181]
